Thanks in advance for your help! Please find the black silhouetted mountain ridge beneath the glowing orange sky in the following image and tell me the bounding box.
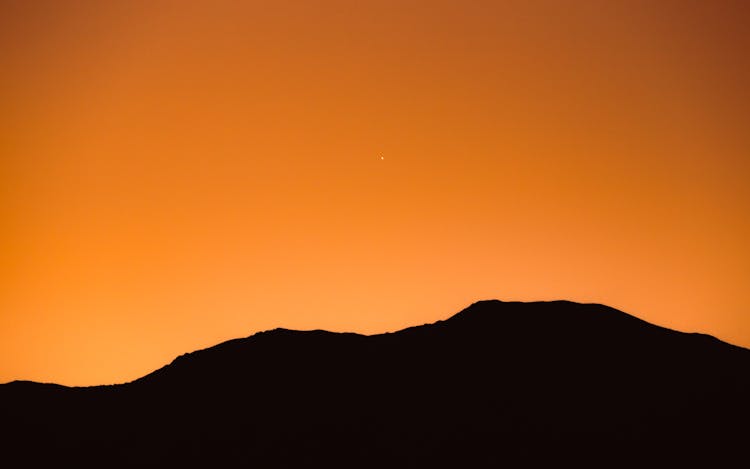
[0,300,750,468]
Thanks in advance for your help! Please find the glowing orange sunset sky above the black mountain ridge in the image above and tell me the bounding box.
[0,0,750,385]
